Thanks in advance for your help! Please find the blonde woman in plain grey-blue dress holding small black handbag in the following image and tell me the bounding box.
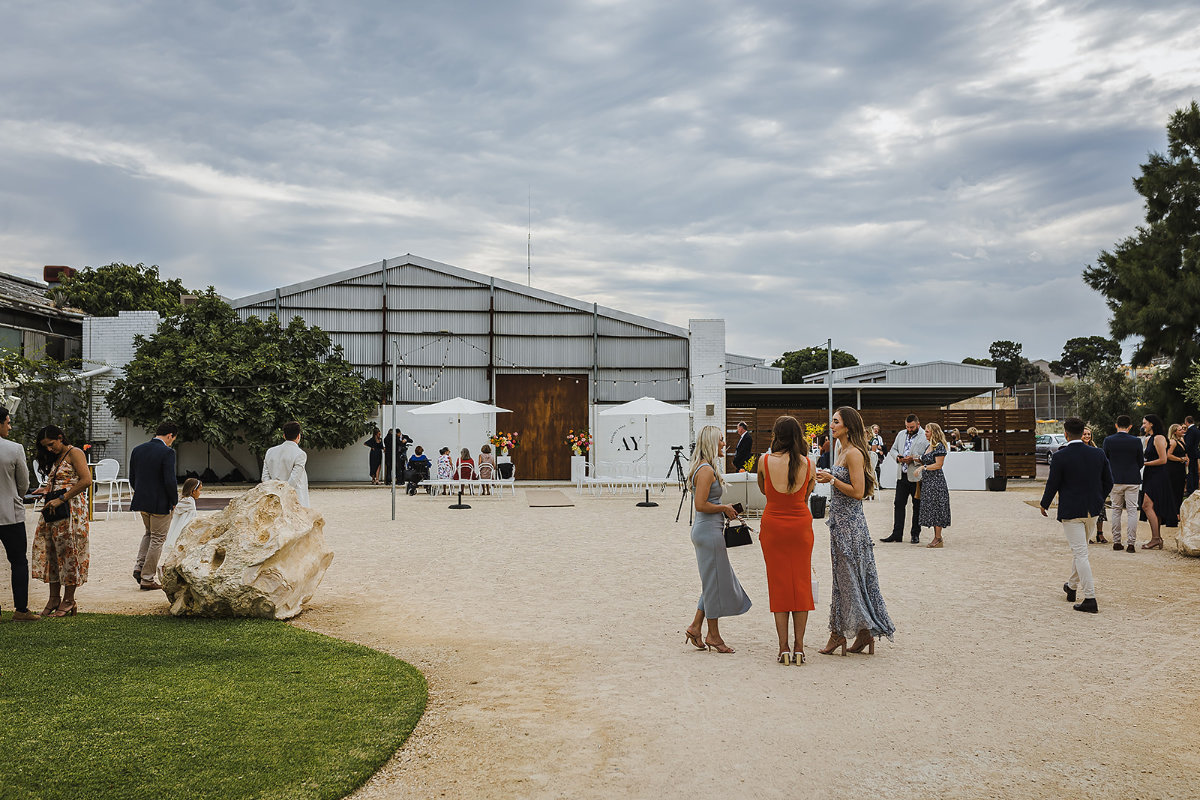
[684,425,750,652]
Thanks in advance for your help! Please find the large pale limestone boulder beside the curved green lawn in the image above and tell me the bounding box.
[162,481,334,619]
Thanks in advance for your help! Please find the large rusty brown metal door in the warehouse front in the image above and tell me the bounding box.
[496,374,588,481]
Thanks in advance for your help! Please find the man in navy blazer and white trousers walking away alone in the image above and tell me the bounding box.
[1040,416,1112,614]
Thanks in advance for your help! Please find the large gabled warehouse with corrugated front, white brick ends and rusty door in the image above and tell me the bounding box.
[84,255,782,481]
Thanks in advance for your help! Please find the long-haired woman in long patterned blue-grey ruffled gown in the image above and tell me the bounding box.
[817,405,895,655]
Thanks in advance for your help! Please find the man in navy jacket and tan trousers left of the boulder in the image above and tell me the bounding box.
[130,422,179,591]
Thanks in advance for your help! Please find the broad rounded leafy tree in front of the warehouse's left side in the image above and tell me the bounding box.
[108,296,378,477]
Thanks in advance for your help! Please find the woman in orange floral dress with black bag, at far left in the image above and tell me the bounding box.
[32,425,91,616]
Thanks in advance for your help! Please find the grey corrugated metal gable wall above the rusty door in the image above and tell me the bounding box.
[239,263,689,403]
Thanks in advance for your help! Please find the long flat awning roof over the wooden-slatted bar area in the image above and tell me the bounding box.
[725,383,1003,409]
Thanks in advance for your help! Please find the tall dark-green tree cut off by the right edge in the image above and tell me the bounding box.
[1084,101,1200,417]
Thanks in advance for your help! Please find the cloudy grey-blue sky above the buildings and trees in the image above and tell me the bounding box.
[0,0,1200,361]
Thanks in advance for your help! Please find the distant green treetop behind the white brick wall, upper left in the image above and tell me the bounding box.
[48,264,194,317]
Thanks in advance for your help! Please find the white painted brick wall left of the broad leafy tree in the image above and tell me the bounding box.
[83,311,162,462]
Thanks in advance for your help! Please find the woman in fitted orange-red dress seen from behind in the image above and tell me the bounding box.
[758,416,816,664]
